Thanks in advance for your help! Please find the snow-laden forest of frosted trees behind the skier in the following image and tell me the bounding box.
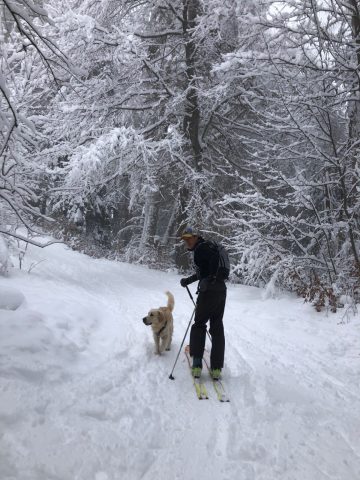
[0,0,360,311]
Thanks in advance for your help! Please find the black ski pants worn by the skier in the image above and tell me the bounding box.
[190,289,226,368]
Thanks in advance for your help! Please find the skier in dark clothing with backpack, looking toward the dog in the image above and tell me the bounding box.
[180,227,226,380]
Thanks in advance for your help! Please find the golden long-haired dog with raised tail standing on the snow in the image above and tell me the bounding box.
[143,292,175,355]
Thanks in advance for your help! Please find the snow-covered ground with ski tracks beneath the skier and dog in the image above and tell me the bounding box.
[0,245,360,480]
